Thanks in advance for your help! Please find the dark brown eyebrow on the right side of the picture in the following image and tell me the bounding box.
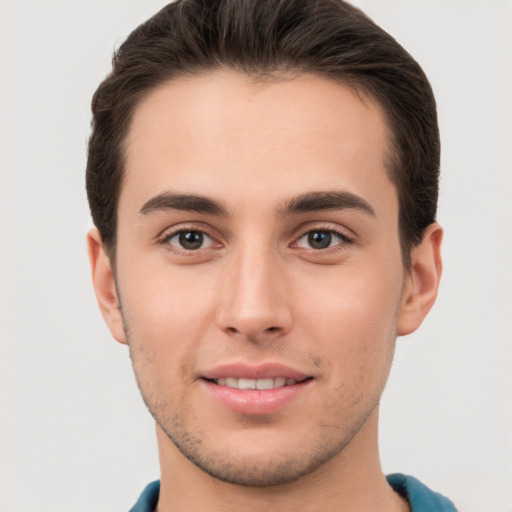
[279,191,376,217]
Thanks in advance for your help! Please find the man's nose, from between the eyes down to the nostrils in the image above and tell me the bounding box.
[217,242,292,342]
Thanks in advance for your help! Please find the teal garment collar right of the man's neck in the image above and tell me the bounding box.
[386,473,457,512]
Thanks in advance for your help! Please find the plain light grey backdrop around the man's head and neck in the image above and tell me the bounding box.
[0,0,512,512]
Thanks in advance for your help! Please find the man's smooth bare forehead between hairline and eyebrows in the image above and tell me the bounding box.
[120,71,396,216]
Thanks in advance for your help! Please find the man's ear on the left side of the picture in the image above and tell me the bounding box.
[87,228,126,343]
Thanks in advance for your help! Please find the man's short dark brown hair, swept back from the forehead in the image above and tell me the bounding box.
[86,0,440,265]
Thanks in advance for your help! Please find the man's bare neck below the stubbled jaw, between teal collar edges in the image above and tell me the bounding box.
[152,409,409,512]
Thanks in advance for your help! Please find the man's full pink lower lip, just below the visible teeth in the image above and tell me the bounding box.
[202,379,312,415]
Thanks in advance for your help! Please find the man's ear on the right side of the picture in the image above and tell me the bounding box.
[397,222,443,336]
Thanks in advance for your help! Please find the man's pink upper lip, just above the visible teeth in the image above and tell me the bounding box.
[201,362,312,381]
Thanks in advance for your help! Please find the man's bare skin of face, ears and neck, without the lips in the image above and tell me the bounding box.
[88,71,442,511]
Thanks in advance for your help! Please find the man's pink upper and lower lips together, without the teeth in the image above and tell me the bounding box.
[200,363,314,416]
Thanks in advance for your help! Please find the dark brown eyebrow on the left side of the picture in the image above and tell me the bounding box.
[139,192,228,217]
